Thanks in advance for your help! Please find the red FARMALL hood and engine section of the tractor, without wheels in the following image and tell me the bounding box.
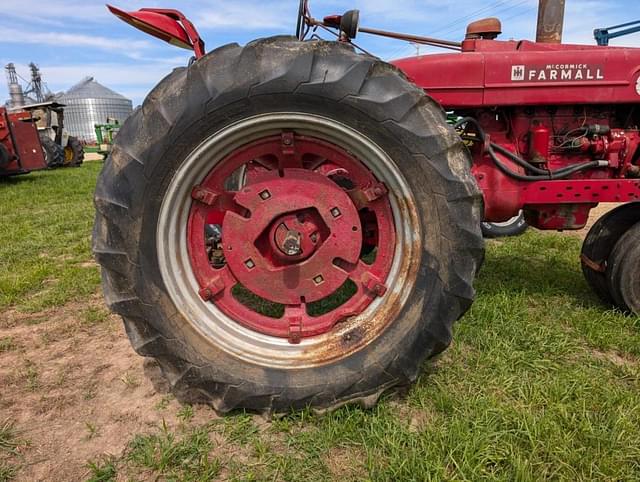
[394,39,640,229]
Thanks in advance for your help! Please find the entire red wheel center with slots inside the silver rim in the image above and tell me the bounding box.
[187,132,396,343]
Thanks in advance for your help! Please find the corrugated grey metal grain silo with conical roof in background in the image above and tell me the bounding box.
[57,77,133,143]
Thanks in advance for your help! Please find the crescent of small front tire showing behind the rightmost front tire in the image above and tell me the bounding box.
[582,202,640,305]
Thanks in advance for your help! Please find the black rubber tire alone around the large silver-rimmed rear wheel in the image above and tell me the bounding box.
[93,37,484,413]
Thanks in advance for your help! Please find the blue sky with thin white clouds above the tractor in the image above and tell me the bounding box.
[0,0,640,105]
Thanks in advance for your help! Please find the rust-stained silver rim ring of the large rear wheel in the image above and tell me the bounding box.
[156,113,422,369]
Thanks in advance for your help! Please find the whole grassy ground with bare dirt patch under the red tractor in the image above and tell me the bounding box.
[0,163,640,481]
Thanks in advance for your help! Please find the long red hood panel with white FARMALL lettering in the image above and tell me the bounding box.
[392,39,640,109]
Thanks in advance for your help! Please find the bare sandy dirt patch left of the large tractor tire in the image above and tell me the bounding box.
[0,296,216,481]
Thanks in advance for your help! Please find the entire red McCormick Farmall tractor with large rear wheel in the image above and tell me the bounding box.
[93,1,640,413]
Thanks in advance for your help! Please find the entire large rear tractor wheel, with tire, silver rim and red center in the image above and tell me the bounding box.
[93,37,484,413]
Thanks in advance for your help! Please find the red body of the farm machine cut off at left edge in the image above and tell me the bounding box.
[0,107,47,176]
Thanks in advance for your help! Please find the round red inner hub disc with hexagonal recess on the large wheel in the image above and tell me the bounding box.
[222,169,362,305]
